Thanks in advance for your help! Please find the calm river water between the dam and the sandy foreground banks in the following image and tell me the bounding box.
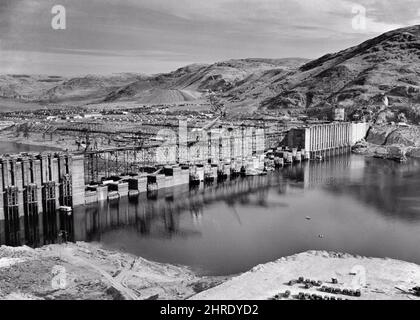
[70,155,420,275]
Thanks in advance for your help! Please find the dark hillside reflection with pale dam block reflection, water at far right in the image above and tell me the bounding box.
[305,157,420,223]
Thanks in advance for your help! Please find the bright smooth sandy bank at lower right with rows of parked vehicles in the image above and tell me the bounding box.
[192,251,420,300]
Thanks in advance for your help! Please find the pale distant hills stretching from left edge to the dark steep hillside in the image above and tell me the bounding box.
[0,59,307,104]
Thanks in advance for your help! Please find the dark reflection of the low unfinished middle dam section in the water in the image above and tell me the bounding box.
[74,174,285,241]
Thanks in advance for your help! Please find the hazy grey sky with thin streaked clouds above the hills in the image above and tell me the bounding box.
[0,0,420,75]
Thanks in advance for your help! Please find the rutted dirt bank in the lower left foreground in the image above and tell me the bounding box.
[0,242,226,300]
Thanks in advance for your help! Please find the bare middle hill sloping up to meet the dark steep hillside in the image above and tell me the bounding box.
[105,59,306,105]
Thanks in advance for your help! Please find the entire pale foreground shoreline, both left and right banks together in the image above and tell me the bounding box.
[0,242,420,300]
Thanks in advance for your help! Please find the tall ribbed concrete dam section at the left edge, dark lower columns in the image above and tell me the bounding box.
[0,153,85,245]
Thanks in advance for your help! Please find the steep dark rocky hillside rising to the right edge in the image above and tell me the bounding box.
[261,25,420,119]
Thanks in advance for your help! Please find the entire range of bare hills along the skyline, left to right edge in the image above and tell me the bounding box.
[0,25,420,117]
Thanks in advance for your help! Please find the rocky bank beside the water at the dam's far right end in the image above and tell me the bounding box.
[353,125,420,160]
